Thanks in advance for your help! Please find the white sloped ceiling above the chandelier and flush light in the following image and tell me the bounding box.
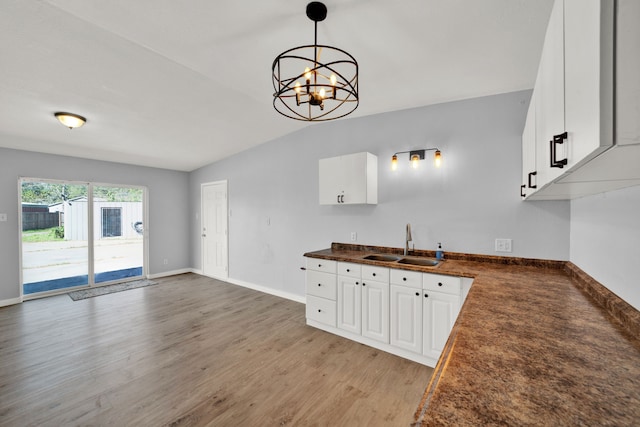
[0,0,553,171]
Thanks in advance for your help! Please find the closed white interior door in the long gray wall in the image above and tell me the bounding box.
[201,181,229,279]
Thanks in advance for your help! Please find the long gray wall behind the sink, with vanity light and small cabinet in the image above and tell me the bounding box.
[190,91,570,295]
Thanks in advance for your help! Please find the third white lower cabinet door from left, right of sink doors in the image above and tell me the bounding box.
[389,285,422,353]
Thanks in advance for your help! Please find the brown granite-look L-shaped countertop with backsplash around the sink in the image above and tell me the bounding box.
[305,243,640,426]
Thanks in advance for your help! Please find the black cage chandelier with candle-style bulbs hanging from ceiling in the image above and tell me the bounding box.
[271,1,359,122]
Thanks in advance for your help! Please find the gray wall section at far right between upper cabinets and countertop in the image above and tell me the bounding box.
[571,186,640,310]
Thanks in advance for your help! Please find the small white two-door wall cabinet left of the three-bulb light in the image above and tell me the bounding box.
[318,153,378,205]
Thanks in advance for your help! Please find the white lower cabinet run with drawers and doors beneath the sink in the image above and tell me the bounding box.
[306,258,471,367]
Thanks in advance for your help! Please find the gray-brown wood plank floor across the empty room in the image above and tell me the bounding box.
[0,274,432,426]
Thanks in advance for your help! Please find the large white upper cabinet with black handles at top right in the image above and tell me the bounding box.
[520,0,640,200]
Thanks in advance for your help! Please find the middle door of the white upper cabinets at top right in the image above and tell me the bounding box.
[535,0,567,187]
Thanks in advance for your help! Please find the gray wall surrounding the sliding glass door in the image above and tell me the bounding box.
[0,145,190,301]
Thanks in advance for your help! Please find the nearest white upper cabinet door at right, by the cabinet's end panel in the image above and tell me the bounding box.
[564,0,616,166]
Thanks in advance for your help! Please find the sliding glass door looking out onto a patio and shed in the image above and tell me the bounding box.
[20,178,145,297]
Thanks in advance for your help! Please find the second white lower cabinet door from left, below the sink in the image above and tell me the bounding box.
[362,281,389,344]
